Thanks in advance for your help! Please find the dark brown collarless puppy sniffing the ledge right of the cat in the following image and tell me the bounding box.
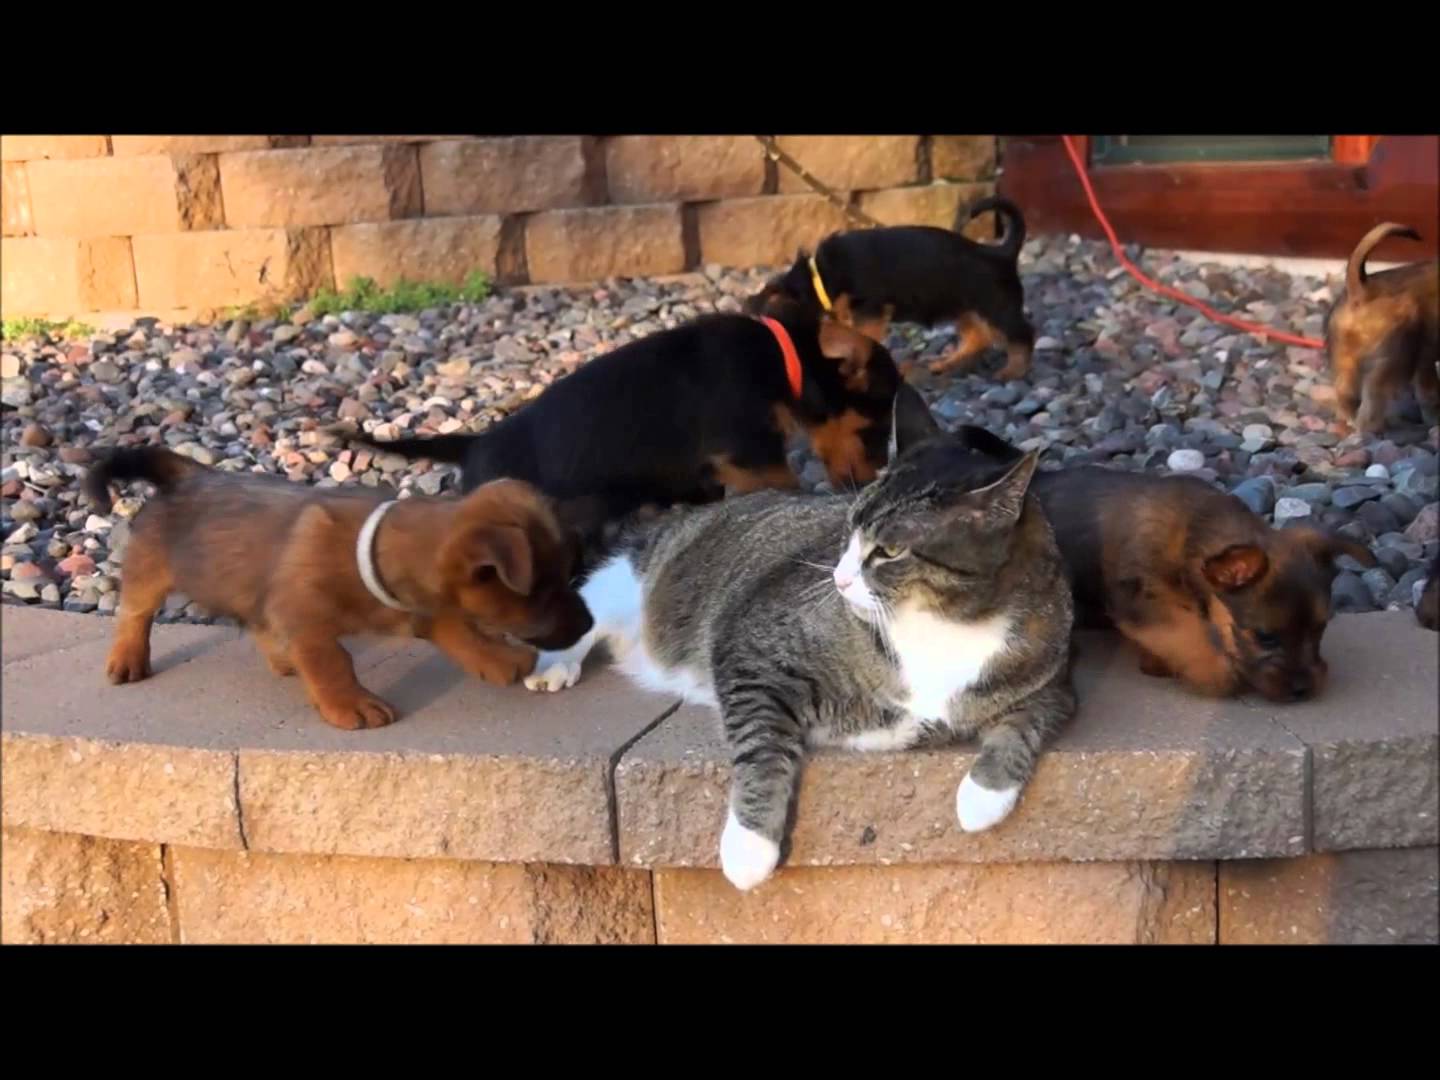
[1032,467,1375,701]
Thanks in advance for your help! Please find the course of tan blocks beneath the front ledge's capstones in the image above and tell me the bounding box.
[8,828,1440,945]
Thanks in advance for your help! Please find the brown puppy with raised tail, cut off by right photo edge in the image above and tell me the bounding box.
[1325,225,1440,433]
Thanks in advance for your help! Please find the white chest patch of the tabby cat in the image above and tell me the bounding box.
[890,608,1009,720]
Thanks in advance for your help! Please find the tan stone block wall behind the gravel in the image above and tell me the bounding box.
[0,135,995,318]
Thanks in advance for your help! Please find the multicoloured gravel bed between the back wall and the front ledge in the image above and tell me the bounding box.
[0,238,1440,621]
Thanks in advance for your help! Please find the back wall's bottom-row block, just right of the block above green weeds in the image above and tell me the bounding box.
[526,204,685,282]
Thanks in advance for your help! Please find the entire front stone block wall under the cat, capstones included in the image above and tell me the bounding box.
[0,605,1440,945]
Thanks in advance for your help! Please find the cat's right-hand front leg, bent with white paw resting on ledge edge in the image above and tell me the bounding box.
[955,680,1076,832]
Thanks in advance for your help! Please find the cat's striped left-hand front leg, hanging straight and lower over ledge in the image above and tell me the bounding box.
[719,684,805,888]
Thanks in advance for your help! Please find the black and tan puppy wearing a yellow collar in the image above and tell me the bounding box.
[747,196,1035,380]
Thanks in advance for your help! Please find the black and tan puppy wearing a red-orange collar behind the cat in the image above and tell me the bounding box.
[361,311,900,527]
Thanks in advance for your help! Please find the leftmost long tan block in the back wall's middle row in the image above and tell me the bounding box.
[26,154,223,236]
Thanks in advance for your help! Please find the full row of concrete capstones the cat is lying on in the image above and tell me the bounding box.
[0,606,1437,868]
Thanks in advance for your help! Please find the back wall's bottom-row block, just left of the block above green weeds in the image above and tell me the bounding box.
[134,226,334,310]
